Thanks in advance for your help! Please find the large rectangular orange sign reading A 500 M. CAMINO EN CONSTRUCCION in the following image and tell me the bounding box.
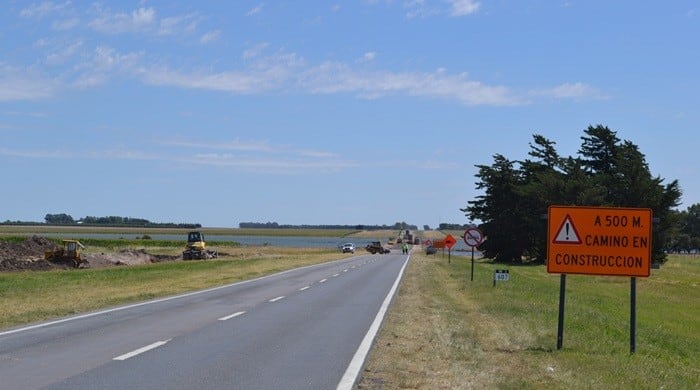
[547,206,652,277]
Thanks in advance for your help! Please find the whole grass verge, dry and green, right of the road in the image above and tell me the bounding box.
[359,254,700,389]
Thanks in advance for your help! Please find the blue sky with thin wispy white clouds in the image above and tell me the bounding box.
[0,0,700,228]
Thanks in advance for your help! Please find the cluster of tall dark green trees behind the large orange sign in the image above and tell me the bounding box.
[460,125,688,263]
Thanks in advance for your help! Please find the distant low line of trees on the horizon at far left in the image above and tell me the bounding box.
[2,213,202,229]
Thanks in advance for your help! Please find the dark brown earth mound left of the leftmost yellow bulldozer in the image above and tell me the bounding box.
[0,236,64,271]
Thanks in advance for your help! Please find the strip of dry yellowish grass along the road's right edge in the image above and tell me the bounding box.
[359,254,500,389]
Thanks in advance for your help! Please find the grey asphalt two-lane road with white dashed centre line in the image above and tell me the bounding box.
[0,253,408,390]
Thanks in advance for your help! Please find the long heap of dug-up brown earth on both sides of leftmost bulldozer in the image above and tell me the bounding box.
[0,236,181,272]
